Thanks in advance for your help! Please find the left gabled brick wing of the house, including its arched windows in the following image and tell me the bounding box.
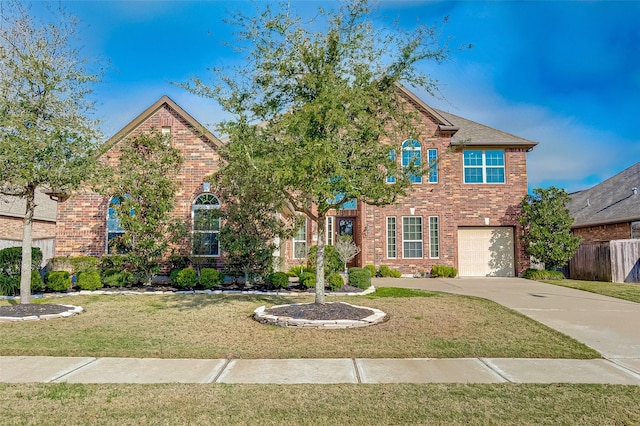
[55,96,221,258]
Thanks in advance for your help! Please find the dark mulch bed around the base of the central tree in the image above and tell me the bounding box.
[265,302,374,321]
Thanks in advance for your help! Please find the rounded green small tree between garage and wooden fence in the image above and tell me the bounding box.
[518,187,582,269]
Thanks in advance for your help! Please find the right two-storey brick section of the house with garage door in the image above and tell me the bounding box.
[287,86,537,276]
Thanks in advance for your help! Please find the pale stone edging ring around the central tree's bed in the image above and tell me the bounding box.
[253,302,387,329]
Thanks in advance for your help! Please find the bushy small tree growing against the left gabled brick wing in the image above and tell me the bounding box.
[103,131,184,283]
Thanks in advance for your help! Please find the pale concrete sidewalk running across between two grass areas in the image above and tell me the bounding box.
[0,356,640,385]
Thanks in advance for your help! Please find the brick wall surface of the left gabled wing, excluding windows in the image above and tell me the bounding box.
[56,104,220,256]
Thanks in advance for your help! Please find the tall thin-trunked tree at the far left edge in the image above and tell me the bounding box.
[0,1,99,303]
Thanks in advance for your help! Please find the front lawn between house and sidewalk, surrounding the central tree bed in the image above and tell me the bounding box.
[0,289,599,359]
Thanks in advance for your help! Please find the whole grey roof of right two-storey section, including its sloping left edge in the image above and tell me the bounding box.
[396,83,538,149]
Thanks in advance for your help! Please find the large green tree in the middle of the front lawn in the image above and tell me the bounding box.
[185,0,447,303]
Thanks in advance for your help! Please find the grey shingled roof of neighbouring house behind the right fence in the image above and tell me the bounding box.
[567,163,640,228]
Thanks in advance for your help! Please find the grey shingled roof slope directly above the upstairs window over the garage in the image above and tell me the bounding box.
[434,108,538,148]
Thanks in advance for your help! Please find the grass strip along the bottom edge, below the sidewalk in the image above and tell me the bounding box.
[0,383,640,426]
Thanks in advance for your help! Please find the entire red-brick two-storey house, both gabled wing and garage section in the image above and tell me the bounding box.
[56,87,536,276]
